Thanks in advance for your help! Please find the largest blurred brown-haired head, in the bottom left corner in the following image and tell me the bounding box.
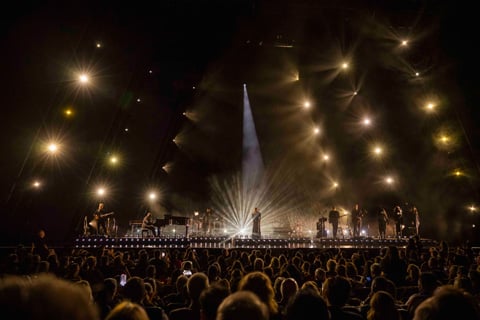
[0,274,100,320]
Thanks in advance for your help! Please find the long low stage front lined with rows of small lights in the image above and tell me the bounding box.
[74,236,438,249]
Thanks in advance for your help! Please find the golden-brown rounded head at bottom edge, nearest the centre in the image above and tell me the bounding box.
[216,291,269,320]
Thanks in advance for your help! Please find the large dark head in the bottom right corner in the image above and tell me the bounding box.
[413,285,480,320]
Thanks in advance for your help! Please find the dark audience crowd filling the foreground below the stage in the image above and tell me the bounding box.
[0,237,480,320]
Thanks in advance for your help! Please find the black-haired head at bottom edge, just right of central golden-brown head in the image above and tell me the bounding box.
[284,288,330,320]
